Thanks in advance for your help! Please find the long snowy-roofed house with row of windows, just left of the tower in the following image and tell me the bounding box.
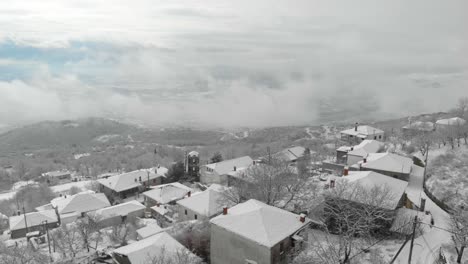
[98,167,168,200]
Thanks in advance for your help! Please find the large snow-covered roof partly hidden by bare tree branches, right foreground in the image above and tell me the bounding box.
[339,171,408,210]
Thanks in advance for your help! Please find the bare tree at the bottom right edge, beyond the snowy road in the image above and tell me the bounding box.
[450,196,468,263]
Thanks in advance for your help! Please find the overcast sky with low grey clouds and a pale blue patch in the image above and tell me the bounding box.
[0,0,468,126]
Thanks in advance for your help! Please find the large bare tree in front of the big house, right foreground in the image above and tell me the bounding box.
[298,181,395,264]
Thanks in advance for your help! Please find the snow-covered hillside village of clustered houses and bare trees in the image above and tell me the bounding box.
[0,114,467,264]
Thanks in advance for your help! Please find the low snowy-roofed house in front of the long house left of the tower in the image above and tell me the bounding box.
[88,201,146,227]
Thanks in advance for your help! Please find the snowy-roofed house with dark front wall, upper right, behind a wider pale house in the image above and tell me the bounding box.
[336,139,384,165]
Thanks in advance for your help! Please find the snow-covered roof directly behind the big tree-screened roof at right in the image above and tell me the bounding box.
[353,152,413,174]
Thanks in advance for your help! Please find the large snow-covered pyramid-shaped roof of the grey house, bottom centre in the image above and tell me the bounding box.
[210,199,310,247]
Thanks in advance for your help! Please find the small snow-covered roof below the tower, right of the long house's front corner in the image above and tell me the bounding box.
[143,182,192,204]
